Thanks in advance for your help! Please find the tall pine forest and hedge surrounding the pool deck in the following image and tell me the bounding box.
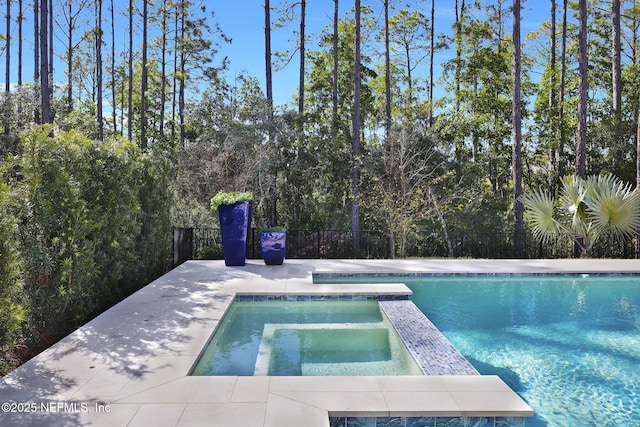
[0,0,640,371]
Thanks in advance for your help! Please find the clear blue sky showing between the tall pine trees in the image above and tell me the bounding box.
[0,0,549,105]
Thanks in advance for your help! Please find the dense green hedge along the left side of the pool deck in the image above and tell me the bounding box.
[14,127,169,333]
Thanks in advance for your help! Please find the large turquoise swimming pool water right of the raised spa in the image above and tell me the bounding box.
[316,275,640,427]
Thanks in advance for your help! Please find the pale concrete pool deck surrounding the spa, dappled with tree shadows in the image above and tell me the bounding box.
[0,259,640,427]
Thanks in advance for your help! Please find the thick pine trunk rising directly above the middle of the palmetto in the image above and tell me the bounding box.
[576,0,588,179]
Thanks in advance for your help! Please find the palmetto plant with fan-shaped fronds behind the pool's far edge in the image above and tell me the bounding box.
[520,174,640,258]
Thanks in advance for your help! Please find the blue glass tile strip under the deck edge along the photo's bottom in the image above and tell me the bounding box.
[329,416,526,427]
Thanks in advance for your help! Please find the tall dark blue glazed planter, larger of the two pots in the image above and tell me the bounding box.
[218,202,251,266]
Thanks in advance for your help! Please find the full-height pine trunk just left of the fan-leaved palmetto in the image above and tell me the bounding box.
[511,0,524,258]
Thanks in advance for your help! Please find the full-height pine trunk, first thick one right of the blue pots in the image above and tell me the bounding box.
[351,0,360,258]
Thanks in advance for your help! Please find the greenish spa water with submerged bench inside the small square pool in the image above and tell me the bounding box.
[191,301,422,376]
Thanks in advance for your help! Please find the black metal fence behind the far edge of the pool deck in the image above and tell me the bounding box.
[173,228,638,265]
